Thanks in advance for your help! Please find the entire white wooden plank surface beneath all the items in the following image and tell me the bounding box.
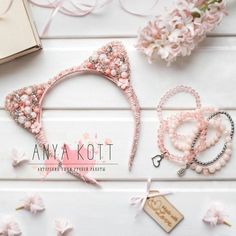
[0,0,236,236]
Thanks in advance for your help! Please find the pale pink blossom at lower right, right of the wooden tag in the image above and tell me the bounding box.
[203,202,229,226]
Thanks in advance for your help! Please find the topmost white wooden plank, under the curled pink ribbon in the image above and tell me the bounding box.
[31,0,236,38]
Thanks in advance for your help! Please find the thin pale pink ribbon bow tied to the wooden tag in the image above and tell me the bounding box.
[130,178,172,217]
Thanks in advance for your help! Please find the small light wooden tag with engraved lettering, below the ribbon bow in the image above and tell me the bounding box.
[143,191,184,233]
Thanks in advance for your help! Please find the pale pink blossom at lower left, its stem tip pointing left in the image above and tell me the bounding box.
[16,194,45,214]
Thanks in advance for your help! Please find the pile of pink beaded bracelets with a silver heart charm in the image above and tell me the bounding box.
[155,86,234,176]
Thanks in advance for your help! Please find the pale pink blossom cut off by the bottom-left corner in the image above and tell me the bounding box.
[0,216,21,236]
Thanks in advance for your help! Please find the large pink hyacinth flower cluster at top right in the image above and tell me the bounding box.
[136,0,226,65]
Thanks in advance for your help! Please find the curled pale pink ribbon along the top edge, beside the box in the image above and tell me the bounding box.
[29,0,159,37]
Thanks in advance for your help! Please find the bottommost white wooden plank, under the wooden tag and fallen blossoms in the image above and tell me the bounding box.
[0,182,236,236]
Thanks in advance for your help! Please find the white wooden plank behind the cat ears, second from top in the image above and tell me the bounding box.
[0,37,236,109]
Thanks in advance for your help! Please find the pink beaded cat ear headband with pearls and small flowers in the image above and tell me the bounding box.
[5,42,140,182]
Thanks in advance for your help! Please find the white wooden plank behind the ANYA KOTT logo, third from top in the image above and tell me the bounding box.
[0,110,236,181]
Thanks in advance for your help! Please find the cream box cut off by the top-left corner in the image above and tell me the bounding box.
[0,0,41,64]
